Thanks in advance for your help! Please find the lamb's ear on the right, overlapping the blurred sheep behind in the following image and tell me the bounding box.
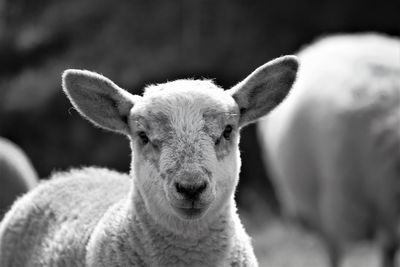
[228,56,299,126]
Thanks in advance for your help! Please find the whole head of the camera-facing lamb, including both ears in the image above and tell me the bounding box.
[63,56,297,226]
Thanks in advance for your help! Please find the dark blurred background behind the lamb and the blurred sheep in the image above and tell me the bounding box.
[0,0,400,226]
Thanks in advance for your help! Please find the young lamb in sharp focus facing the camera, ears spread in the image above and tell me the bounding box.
[0,56,298,267]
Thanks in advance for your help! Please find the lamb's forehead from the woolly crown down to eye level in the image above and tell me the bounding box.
[131,80,239,135]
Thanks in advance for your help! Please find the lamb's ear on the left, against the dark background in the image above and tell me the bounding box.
[62,69,140,134]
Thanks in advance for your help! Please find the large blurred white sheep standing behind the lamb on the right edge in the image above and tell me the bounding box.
[257,33,400,266]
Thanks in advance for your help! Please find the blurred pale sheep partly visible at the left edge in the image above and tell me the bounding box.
[0,138,38,220]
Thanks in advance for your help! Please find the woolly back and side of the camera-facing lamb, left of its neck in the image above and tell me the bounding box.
[0,168,130,266]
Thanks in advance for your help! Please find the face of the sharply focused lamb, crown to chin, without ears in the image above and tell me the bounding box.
[129,80,240,220]
